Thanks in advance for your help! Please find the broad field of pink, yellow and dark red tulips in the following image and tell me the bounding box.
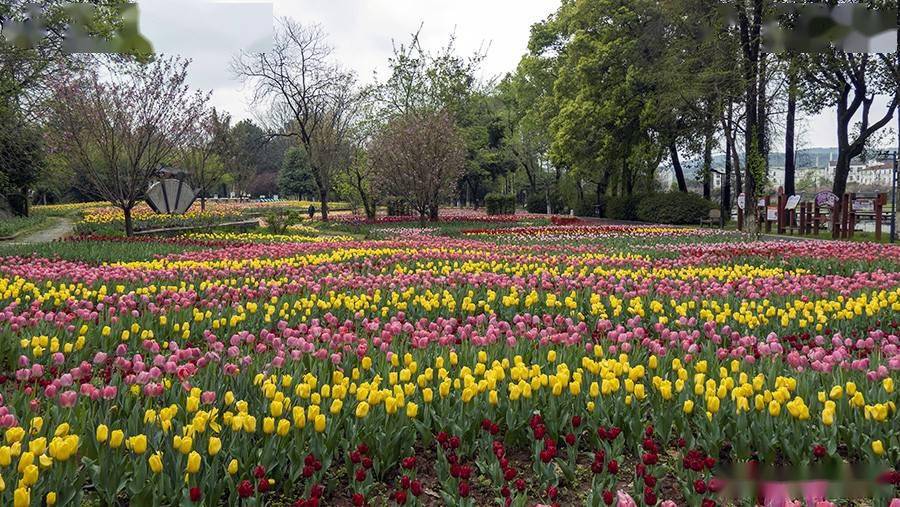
[0,223,900,507]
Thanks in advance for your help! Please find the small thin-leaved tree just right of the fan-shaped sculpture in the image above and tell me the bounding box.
[178,108,231,210]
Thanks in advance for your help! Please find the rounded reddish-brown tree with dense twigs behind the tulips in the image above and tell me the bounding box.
[369,111,466,222]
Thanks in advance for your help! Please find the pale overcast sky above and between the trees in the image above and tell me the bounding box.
[137,0,896,151]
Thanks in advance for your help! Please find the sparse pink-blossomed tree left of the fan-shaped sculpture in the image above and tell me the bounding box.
[49,57,209,236]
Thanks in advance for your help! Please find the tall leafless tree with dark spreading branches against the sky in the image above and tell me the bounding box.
[232,18,356,220]
